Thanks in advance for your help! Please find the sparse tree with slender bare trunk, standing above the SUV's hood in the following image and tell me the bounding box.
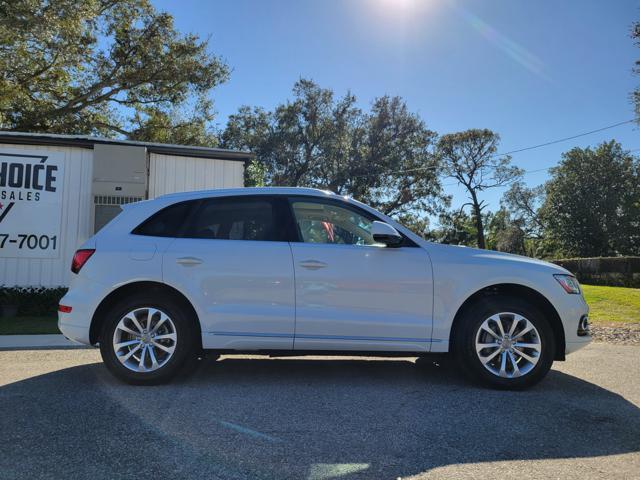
[438,129,522,248]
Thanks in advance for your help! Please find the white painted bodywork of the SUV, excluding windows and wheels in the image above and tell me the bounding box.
[59,188,590,353]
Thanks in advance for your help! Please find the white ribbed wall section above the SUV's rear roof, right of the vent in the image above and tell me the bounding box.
[149,153,244,198]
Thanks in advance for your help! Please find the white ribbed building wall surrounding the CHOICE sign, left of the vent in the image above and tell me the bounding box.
[0,144,93,287]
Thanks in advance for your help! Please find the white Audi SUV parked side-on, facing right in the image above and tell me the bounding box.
[58,188,591,388]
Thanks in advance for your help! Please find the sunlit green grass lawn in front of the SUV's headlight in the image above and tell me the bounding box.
[582,285,640,324]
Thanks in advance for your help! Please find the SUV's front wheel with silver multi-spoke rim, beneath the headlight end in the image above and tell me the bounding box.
[453,295,555,390]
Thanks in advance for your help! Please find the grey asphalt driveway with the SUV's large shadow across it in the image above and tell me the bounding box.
[0,344,640,480]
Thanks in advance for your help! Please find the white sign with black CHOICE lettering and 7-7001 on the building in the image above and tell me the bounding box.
[0,148,64,258]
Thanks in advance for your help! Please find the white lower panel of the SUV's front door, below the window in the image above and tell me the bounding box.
[291,243,433,352]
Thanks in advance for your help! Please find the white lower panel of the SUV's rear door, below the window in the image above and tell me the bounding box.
[162,238,296,350]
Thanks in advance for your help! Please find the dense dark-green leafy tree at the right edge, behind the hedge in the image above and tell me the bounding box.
[541,140,640,257]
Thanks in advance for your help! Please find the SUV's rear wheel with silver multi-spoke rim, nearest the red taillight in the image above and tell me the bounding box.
[100,295,198,385]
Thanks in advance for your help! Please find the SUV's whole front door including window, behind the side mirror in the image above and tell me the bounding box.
[290,197,433,351]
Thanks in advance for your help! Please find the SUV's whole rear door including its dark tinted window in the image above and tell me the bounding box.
[163,195,295,349]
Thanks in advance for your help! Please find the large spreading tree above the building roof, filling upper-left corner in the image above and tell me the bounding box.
[0,0,228,143]
